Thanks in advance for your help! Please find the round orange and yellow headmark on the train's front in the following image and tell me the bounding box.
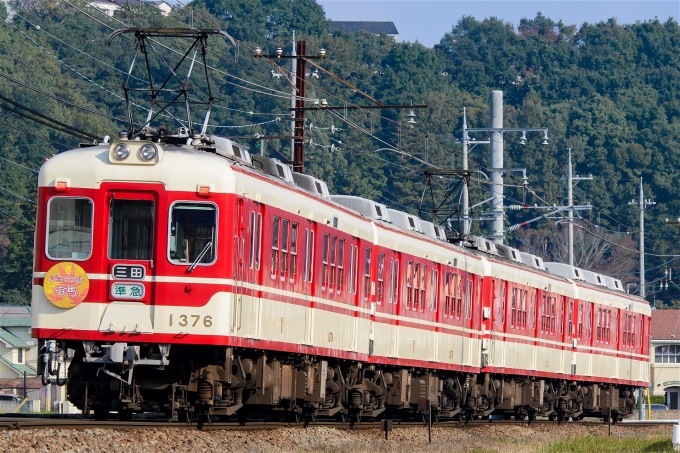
[43,262,90,308]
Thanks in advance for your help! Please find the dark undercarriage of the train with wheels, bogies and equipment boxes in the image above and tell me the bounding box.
[39,341,635,422]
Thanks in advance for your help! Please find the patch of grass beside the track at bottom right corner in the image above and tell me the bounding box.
[538,436,675,453]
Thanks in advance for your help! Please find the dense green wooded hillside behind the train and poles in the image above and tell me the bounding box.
[0,0,680,304]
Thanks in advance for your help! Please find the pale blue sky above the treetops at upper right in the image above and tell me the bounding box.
[317,0,680,47]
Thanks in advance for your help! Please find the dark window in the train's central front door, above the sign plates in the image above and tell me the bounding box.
[109,198,154,260]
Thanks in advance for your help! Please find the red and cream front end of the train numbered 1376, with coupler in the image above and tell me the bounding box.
[32,140,238,419]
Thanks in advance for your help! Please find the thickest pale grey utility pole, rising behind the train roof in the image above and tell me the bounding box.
[489,91,504,244]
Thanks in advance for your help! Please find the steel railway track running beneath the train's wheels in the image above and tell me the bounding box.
[0,414,678,431]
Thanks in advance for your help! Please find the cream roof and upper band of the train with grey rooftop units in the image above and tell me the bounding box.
[38,136,646,310]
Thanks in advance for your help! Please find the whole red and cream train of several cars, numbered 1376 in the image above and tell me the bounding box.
[32,132,650,420]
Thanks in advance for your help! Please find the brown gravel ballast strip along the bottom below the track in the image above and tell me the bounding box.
[0,424,672,453]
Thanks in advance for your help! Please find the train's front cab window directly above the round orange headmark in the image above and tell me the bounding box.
[46,197,93,260]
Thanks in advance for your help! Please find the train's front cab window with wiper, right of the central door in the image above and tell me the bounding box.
[168,203,217,264]
